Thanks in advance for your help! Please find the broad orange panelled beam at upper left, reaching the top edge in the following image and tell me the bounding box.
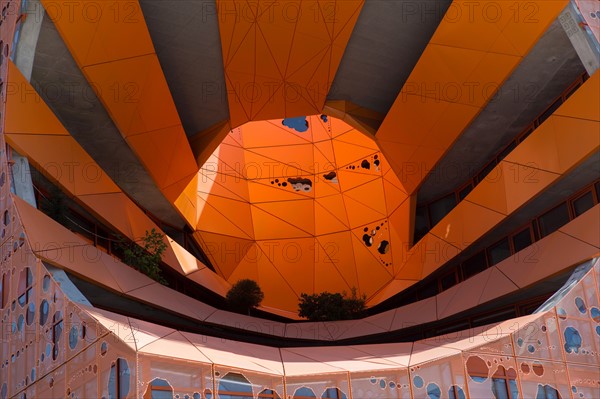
[42,0,198,201]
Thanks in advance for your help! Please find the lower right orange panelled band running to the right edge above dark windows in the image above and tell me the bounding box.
[369,72,600,305]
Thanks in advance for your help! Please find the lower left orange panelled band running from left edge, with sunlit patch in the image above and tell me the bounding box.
[5,63,229,295]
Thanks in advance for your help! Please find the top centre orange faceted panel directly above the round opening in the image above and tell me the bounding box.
[217,0,363,127]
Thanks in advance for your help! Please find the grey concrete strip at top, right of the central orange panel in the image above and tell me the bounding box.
[327,0,451,114]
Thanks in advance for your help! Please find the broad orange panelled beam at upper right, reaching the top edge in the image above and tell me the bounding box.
[376,0,568,193]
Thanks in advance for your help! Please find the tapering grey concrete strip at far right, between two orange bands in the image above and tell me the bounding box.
[418,20,585,204]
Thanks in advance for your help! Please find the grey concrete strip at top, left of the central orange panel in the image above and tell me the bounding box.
[140,0,229,137]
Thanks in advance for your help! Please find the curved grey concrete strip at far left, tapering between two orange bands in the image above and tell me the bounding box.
[31,15,185,226]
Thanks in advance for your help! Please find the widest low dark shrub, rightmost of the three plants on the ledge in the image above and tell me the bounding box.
[298,288,367,321]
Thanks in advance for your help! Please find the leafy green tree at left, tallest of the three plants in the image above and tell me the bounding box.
[118,228,167,285]
